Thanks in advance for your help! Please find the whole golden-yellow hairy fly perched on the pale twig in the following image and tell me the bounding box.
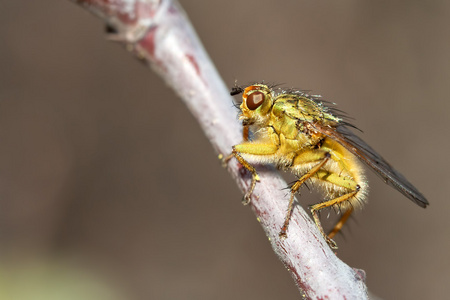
[224,83,428,248]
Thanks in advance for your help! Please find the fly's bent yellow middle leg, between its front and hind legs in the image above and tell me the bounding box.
[279,151,330,238]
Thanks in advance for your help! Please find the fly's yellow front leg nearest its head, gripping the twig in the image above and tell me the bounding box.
[223,142,278,205]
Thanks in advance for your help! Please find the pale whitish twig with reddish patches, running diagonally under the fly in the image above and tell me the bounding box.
[68,0,367,299]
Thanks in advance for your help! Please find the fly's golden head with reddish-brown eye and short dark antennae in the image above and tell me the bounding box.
[231,84,273,126]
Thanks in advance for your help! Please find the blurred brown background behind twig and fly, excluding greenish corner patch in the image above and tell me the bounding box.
[0,0,450,299]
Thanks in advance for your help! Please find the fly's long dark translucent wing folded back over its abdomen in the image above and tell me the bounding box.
[313,124,428,208]
